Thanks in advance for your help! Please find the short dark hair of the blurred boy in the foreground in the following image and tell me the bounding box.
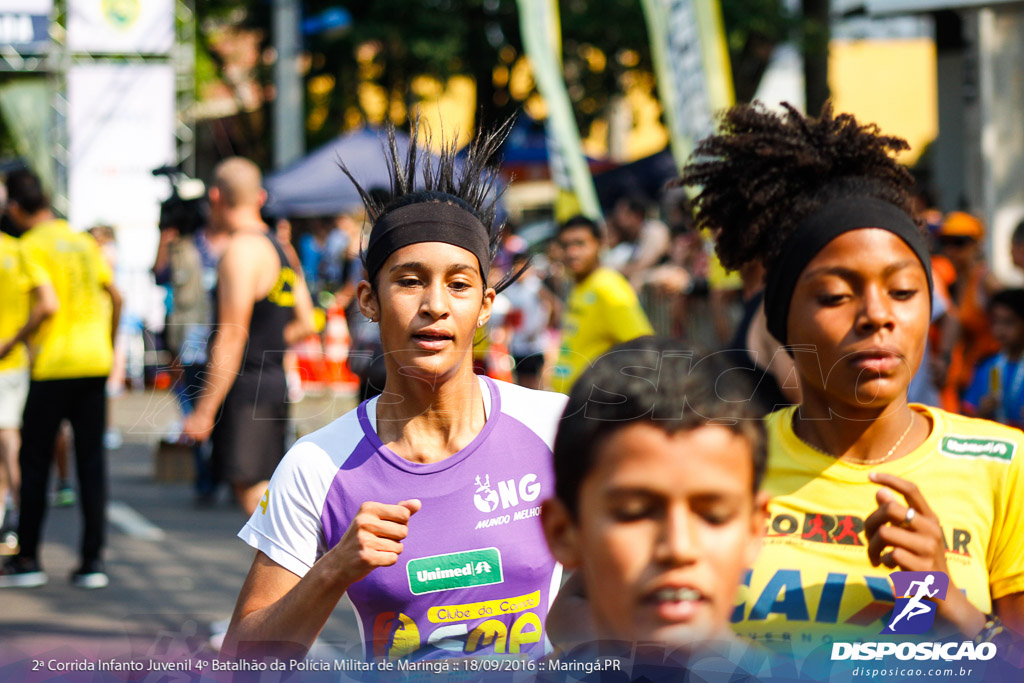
[554,337,767,515]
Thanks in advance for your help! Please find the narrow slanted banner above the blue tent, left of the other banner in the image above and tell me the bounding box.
[518,0,601,220]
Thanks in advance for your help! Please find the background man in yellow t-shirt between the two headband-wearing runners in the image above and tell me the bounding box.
[551,216,654,393]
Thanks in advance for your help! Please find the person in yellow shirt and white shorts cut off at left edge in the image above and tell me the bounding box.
[0,187,29,555]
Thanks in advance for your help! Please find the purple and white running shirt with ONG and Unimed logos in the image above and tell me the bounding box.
[239,377,566,658]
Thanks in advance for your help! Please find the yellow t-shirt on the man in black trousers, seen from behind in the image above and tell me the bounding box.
[20,220,114,380]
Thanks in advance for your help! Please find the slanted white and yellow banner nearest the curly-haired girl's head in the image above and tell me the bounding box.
[641,0,734,167]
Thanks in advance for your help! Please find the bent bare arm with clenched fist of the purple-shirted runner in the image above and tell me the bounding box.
[223,500,420,656]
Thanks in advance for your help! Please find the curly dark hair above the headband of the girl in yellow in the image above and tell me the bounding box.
[677,102,913,269]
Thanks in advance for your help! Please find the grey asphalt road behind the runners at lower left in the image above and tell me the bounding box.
[0,392,366,681]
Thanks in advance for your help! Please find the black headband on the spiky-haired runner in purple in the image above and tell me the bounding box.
[366,202,490,283]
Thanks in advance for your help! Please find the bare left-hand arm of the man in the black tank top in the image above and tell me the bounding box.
[182,236,262,440]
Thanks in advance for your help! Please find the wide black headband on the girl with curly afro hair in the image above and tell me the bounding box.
[765,197,932,345]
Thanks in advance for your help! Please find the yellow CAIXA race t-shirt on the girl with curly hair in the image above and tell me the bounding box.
[732,404,1024,656]
